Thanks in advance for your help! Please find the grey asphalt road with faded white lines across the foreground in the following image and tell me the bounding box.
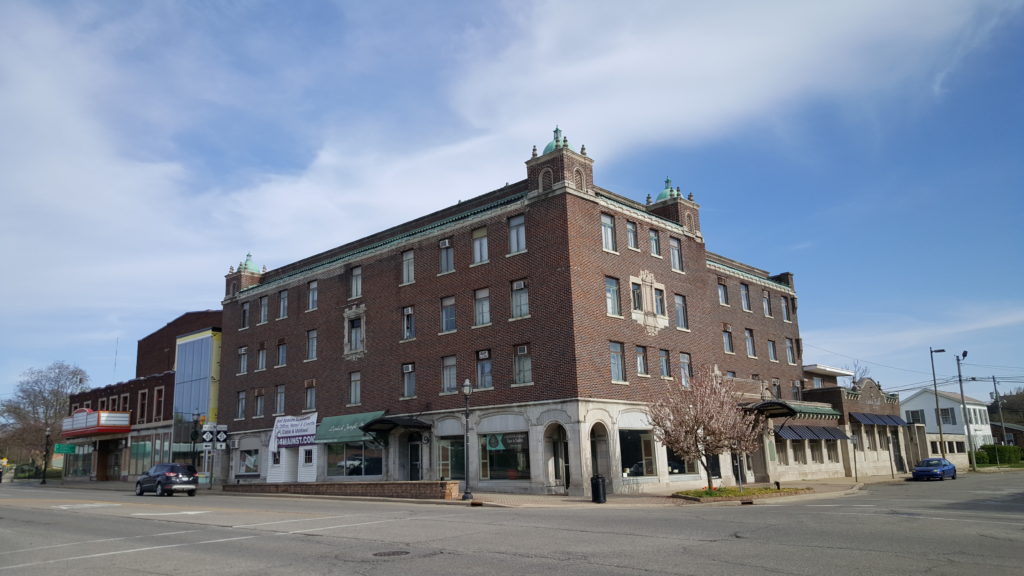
[0,472,1024,576]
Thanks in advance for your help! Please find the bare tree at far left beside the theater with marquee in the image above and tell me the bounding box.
[0,362,89,466]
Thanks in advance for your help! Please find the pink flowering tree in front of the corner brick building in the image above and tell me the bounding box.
[648,367,762,490]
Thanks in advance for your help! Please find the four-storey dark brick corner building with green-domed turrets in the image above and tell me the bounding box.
[219,129,835,494]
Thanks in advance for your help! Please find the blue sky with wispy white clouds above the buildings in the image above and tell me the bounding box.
[0,0,1024,402]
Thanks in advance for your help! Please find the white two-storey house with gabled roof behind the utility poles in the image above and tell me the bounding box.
[900,388,992,467]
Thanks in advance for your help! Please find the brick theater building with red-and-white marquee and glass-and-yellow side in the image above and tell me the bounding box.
[60,311,221,481]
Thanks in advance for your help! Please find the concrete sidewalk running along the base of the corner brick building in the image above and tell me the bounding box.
[18,475,909,507]
